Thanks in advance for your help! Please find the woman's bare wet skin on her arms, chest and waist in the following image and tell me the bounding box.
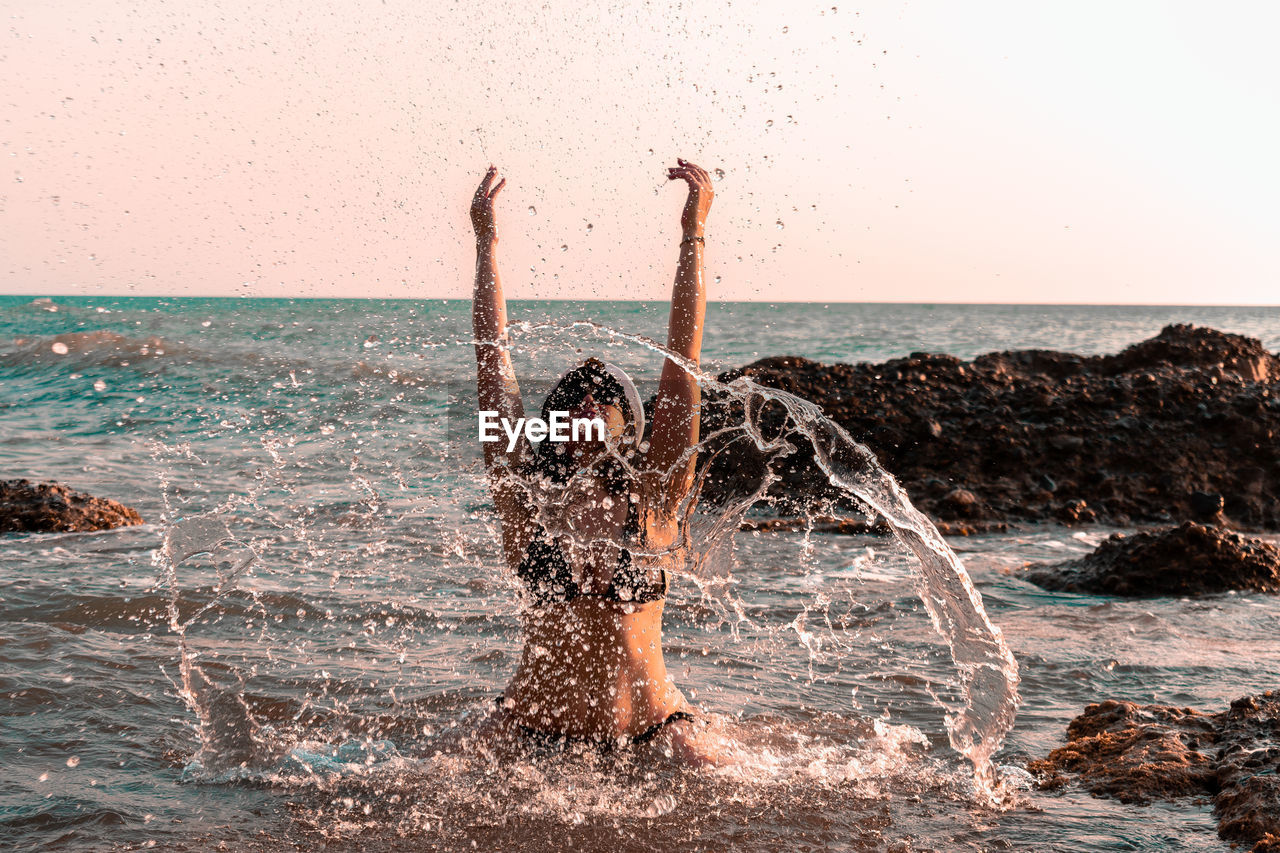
[471,160,717,763]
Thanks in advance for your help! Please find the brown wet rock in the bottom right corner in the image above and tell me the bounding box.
[1027,690,1280,853]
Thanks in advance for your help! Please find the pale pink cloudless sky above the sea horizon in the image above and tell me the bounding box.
[0,0,1280,305]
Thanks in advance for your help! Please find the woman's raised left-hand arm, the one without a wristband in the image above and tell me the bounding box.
[471,167,530,562]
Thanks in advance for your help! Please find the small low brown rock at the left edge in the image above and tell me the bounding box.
[0,480,142,533]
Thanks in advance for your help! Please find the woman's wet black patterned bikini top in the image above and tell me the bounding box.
[516,491,668,607]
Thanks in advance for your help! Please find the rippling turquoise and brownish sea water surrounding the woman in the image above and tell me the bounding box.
[0,296,1280,850]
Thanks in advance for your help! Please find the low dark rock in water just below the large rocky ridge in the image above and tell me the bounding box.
[1023,521,1280,597]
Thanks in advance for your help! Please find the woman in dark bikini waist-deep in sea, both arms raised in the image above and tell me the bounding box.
[471,160,716,762]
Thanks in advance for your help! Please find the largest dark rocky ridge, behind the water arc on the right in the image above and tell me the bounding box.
[703,325,1280,529]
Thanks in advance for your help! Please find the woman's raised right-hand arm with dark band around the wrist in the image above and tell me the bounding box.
[646,160,714,506]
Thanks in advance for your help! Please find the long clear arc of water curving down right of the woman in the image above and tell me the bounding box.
[499,320,1019,788]
